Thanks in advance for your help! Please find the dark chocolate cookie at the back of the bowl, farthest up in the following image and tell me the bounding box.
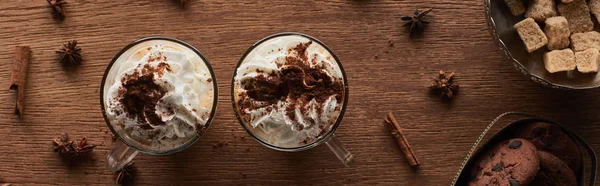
[517,122,581,173]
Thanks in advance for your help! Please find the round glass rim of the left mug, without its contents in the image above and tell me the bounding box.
[100,36,219,155]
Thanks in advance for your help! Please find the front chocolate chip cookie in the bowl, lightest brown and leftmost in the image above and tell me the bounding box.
[469,138,539,186]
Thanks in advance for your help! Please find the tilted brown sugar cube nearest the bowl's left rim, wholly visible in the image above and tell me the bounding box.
[515,18,548,53]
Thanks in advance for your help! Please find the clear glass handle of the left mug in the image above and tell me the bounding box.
[106,140,139,172]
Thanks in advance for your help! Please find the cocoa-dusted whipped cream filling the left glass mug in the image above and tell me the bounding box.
[104,41,214,150]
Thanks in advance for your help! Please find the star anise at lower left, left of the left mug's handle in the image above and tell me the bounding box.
[52,133,96,160]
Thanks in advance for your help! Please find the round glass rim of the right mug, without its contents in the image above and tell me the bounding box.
[231,32,349,152]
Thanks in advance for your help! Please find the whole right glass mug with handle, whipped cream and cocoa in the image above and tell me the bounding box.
[231,32,354,167]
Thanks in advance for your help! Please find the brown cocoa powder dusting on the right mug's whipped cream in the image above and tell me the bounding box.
[238,41,344,124]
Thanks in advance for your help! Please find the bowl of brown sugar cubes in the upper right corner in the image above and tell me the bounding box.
[484,0,600,89]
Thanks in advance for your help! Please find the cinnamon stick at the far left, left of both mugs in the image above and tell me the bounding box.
[10,46,31,117]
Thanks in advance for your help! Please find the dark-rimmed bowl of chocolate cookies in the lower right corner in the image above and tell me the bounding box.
[452,112,597,186]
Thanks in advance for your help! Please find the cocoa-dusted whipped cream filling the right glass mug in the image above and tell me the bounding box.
[234,35,345,148]
